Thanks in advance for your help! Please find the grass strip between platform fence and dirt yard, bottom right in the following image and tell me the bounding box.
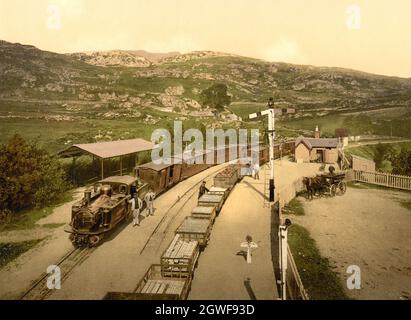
[288,225,350,300]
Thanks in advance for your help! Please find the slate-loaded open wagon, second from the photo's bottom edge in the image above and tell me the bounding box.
[161,234,200,278]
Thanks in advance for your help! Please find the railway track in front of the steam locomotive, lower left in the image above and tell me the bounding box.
[20,248,96,300]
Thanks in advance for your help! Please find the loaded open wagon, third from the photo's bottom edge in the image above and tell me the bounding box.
[176,217,212,248]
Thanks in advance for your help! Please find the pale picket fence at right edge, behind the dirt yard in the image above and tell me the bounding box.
[353,170,411,191]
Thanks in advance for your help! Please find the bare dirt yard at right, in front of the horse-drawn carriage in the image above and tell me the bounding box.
[292,188,411,300]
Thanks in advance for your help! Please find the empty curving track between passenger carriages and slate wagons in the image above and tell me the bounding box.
[140,164,228,255]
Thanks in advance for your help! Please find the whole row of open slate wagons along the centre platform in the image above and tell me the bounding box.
[104,164,243,300]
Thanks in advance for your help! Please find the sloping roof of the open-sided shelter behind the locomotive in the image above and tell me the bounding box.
[58,139,156,159]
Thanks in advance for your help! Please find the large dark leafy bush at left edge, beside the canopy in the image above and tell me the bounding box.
[0,135,68,212]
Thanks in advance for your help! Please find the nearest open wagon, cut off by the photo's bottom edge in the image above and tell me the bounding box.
[103,264,192,300]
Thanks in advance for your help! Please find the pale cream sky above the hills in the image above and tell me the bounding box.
[0,0,411,77]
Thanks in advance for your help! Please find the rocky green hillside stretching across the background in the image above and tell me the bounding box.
[0,41,411,151]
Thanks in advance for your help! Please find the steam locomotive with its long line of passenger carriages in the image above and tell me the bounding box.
[65,141,295,247]
